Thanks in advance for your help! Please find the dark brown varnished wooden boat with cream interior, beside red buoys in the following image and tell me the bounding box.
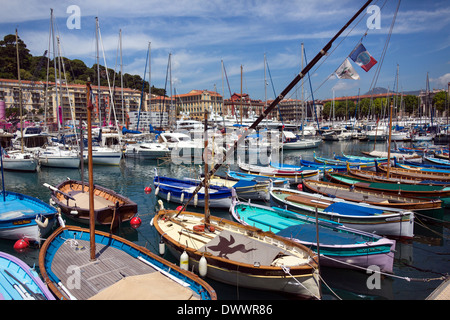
[44,180,137,227]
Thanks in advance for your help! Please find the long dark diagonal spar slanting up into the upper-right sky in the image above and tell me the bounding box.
[177,0,372,215]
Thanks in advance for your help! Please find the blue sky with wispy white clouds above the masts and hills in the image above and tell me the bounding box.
[0,0,450,100]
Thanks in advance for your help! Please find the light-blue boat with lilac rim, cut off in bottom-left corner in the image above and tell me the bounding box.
[0,252,55,300]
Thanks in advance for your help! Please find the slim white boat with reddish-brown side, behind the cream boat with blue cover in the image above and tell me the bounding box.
[238,159,319,183]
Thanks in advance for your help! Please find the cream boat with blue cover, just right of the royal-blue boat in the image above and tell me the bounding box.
[209,175,270,200]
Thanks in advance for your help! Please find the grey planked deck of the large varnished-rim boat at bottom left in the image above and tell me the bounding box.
[52,240,160,300]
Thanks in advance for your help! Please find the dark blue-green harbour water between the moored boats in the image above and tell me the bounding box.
[0,140,450,300]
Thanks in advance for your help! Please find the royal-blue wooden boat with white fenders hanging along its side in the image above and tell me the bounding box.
[153,169,232,209]
